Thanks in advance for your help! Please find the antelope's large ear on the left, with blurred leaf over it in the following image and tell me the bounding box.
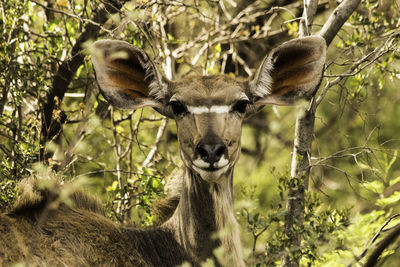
[91,40,168,110]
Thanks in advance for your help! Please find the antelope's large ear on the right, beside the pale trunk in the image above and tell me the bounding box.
[250,36,326,106]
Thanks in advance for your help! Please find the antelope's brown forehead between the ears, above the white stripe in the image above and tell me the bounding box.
[172,75,246,106]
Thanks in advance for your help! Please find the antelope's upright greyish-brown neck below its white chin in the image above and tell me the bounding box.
[166,168,244,266]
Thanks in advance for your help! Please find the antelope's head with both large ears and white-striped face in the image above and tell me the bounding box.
[92,36,326,182]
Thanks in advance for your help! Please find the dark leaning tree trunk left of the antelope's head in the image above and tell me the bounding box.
[40,0,126,160]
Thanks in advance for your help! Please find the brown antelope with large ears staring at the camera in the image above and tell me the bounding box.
[0,36,326,266]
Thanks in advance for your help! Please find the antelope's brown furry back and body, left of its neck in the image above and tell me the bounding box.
[0,178,191,266]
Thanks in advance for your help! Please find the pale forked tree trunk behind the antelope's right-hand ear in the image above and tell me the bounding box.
[281,0,360,267]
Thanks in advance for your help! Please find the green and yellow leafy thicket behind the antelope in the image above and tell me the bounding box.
[0,0,400,266]
